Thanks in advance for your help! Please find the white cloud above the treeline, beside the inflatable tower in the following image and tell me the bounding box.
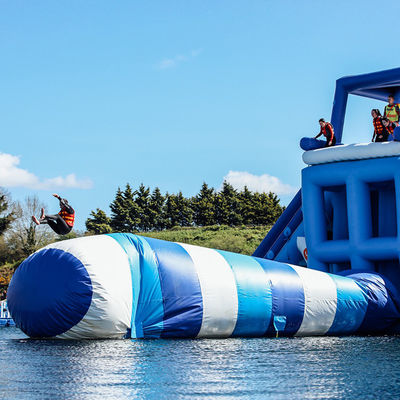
[224,171,297,195]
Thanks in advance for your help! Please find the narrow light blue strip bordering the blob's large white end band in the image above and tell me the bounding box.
[109,233,140,338]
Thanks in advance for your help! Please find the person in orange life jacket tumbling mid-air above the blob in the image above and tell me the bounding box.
[32,193,75,235]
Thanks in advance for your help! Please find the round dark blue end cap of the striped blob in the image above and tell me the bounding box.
[7,249,93,337]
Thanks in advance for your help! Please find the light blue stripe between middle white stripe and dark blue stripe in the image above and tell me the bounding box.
[217,250,272,336]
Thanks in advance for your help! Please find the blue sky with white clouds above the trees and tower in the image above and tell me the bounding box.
[0,0,400,229]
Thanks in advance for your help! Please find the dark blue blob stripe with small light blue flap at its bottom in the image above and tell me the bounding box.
[254,258,305,336]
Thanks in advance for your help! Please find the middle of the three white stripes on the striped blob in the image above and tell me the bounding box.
[179,243,238,337]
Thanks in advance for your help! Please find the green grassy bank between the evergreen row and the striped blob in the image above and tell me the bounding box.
[140,226,270,255]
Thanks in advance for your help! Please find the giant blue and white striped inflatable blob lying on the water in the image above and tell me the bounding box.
[8,233,399,339]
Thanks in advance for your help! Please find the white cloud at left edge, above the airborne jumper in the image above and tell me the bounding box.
[0,153,93,190]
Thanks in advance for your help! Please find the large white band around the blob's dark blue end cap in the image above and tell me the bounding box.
[46,235,132,339]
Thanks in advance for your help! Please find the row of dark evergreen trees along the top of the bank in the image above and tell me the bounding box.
[86,182,284,234]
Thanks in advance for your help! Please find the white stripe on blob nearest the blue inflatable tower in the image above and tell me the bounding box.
[291,265,337,336]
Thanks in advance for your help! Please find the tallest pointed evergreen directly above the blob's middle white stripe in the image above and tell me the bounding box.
[192,182,215,226]
